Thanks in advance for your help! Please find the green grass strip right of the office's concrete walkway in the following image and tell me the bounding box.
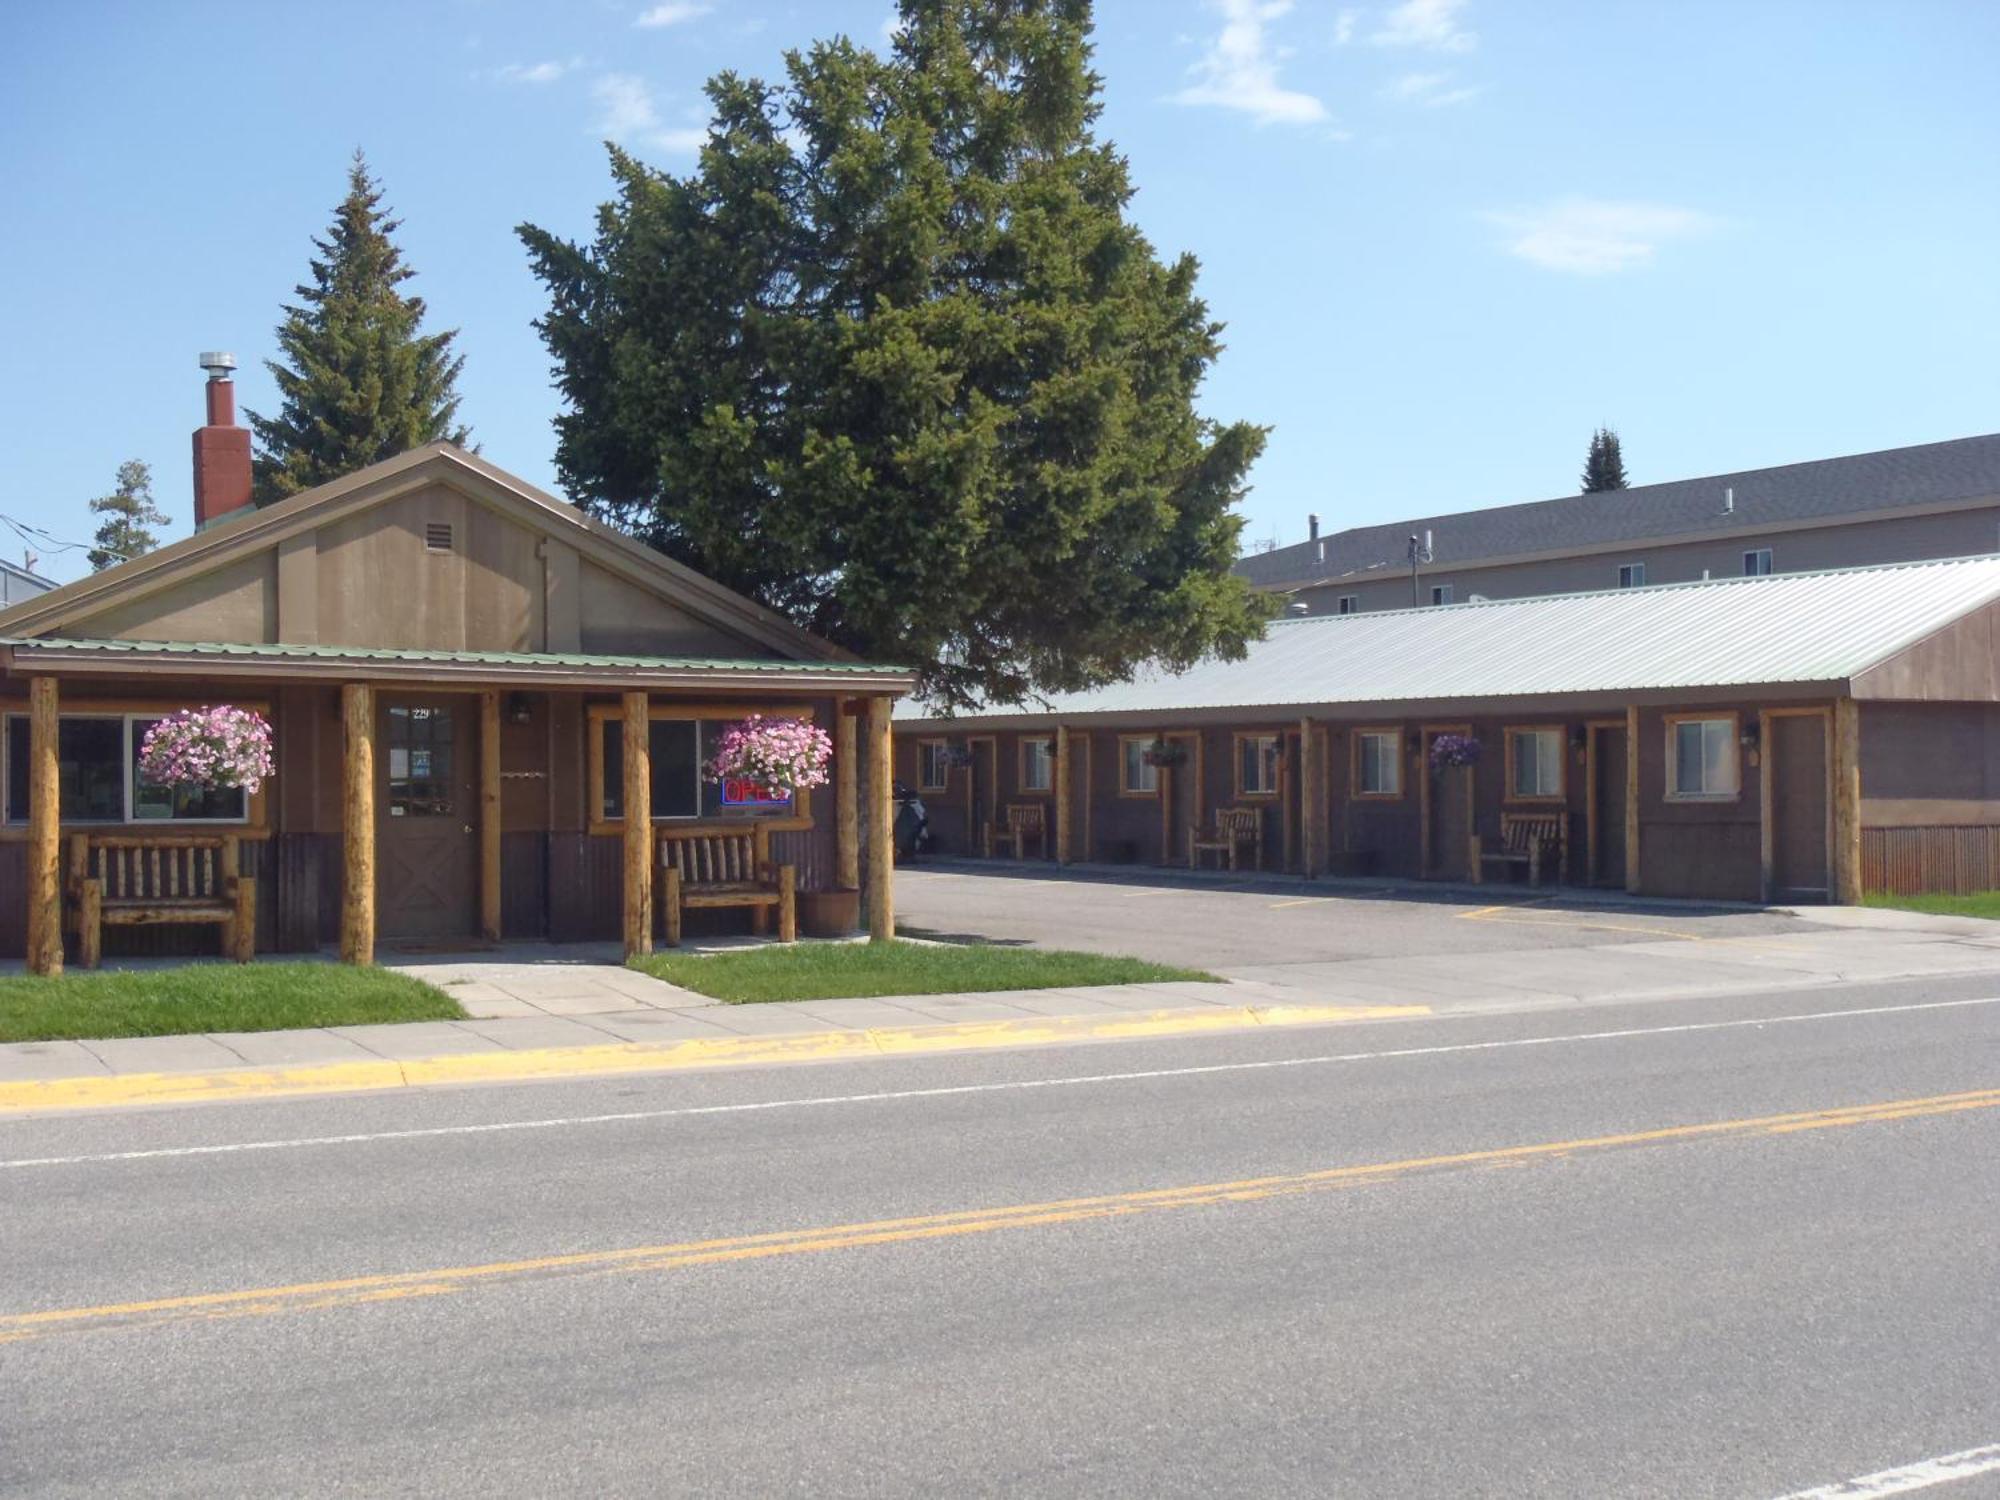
[632,942,1214,1004]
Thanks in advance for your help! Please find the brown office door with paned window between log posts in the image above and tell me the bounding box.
[376,698,480,942]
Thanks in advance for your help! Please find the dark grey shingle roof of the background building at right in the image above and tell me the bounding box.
[1236,434,2000,586]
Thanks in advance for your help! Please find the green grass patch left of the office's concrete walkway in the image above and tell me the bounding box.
[0,964,466,1042]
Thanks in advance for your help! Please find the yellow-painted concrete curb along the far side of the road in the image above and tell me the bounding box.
[0,1004,1430,1114]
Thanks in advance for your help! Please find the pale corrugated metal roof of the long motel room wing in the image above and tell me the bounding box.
[898,556,2000,718]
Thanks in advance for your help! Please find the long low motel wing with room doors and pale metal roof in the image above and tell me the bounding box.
[894,556,2000,902]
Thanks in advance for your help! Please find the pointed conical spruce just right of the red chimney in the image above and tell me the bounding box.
[246,152,470,506]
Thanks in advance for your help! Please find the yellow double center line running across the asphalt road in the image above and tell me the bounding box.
[0,1088,2000,1344]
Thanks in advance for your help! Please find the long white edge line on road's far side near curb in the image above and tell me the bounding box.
[0,994,2000,1170]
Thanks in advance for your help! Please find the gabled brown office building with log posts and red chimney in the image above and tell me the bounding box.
[0,370,912,974]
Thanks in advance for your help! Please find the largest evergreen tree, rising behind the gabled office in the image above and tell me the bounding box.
[520,0,1268,706]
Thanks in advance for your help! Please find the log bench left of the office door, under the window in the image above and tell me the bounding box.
[68,834,256,968]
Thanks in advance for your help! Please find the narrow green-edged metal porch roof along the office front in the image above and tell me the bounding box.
[0,636,916,694]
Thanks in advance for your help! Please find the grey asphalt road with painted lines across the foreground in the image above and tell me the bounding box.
[0,978,2000,1500]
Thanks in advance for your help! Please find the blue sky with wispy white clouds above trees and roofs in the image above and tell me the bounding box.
[0,0,2000,578]
